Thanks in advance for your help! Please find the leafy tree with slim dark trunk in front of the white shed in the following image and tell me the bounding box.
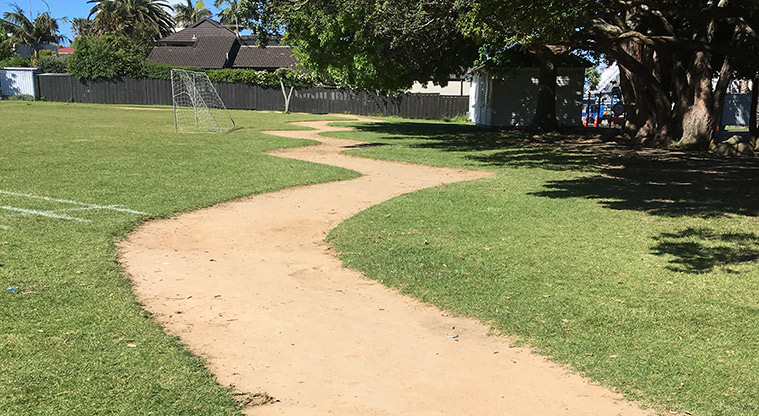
[268,0,588,130]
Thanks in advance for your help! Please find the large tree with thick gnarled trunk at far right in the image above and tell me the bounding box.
[577,0,759,147]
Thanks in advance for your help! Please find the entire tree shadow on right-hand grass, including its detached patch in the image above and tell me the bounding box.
[359,122,759,273]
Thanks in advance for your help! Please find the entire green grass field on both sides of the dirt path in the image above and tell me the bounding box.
[0,102,759,415]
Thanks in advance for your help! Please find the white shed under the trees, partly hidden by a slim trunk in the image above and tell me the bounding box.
[469,67,585,127]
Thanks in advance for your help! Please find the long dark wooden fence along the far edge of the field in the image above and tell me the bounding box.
[36,74,469,119]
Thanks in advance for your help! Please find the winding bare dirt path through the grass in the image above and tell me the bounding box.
[120,116,650,416]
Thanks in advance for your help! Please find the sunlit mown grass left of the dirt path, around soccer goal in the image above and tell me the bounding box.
[0,102,356,415]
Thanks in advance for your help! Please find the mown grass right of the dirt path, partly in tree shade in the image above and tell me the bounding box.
[329,120,759,415]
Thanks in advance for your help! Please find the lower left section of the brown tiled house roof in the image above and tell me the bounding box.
[148,36,235,69]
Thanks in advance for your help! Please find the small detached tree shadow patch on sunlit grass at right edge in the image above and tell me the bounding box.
[651,228,759,273]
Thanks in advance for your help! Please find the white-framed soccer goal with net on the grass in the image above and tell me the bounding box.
[171,69,235,133]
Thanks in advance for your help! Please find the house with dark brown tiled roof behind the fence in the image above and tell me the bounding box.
[148,18,296,71]
